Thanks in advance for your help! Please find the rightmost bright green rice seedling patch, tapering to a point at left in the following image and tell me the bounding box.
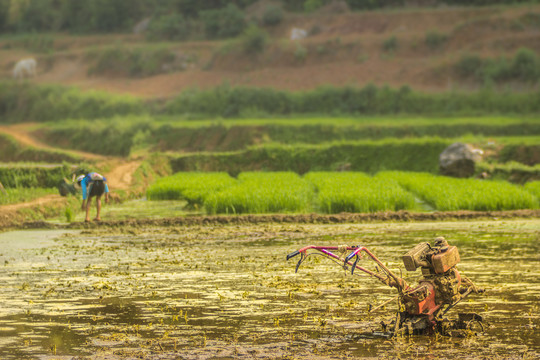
[378,171,539,211]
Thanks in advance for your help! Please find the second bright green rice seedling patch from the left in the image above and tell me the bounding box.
[205,172,313,214]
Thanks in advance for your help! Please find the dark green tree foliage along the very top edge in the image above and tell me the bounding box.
[0,0,533,34]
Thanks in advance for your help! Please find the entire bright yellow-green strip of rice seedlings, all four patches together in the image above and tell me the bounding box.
[148,171,540,214]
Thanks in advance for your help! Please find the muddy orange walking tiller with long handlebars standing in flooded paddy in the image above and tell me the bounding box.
[287,237,483,335]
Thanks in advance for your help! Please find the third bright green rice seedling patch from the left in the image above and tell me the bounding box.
[305,172,416,214]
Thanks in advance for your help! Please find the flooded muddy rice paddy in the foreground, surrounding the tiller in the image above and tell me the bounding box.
[0,219,540,360]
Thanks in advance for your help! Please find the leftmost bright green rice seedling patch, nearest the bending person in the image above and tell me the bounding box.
[146,172,236,206]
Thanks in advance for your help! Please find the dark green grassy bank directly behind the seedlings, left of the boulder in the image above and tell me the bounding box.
[171,138,451,174]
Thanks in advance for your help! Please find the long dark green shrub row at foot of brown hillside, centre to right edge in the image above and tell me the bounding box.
[162,84,540,117]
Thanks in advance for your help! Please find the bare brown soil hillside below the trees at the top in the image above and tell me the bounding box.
[0,5,540,98]
